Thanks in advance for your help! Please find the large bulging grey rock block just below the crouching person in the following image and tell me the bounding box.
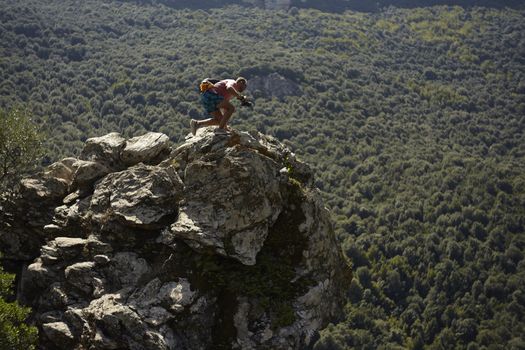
[171,143,282,265]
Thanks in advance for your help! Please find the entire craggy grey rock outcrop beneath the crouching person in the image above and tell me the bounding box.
[4,128,349,349]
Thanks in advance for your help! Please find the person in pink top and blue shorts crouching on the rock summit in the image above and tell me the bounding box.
[190,77,247,135]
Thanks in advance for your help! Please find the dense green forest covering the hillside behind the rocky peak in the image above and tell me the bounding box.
[0,0,525,350]
